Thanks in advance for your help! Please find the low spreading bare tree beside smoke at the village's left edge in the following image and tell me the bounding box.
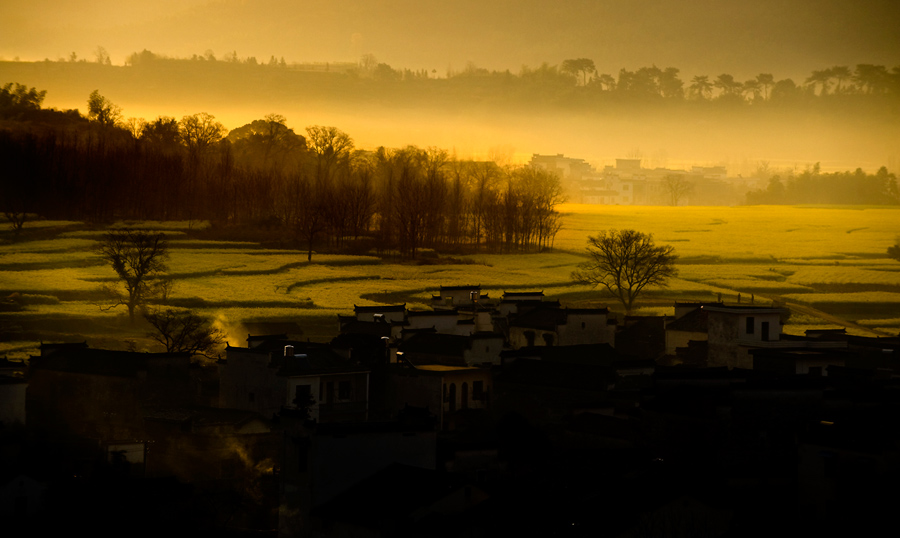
[144,308,225,358]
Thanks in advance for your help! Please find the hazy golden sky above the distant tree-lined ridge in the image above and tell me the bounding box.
[0,0,900,78]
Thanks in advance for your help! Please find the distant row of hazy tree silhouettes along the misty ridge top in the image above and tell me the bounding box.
[28,47,900,105]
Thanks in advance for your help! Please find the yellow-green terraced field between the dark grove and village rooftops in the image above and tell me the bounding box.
[0,204,900,357]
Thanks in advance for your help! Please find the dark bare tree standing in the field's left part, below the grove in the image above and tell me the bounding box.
[97,230,169,323]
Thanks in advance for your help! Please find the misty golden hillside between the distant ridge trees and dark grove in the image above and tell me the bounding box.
[0,52,900,171]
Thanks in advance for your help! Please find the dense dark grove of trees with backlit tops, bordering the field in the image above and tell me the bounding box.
[0,85,564,258]
